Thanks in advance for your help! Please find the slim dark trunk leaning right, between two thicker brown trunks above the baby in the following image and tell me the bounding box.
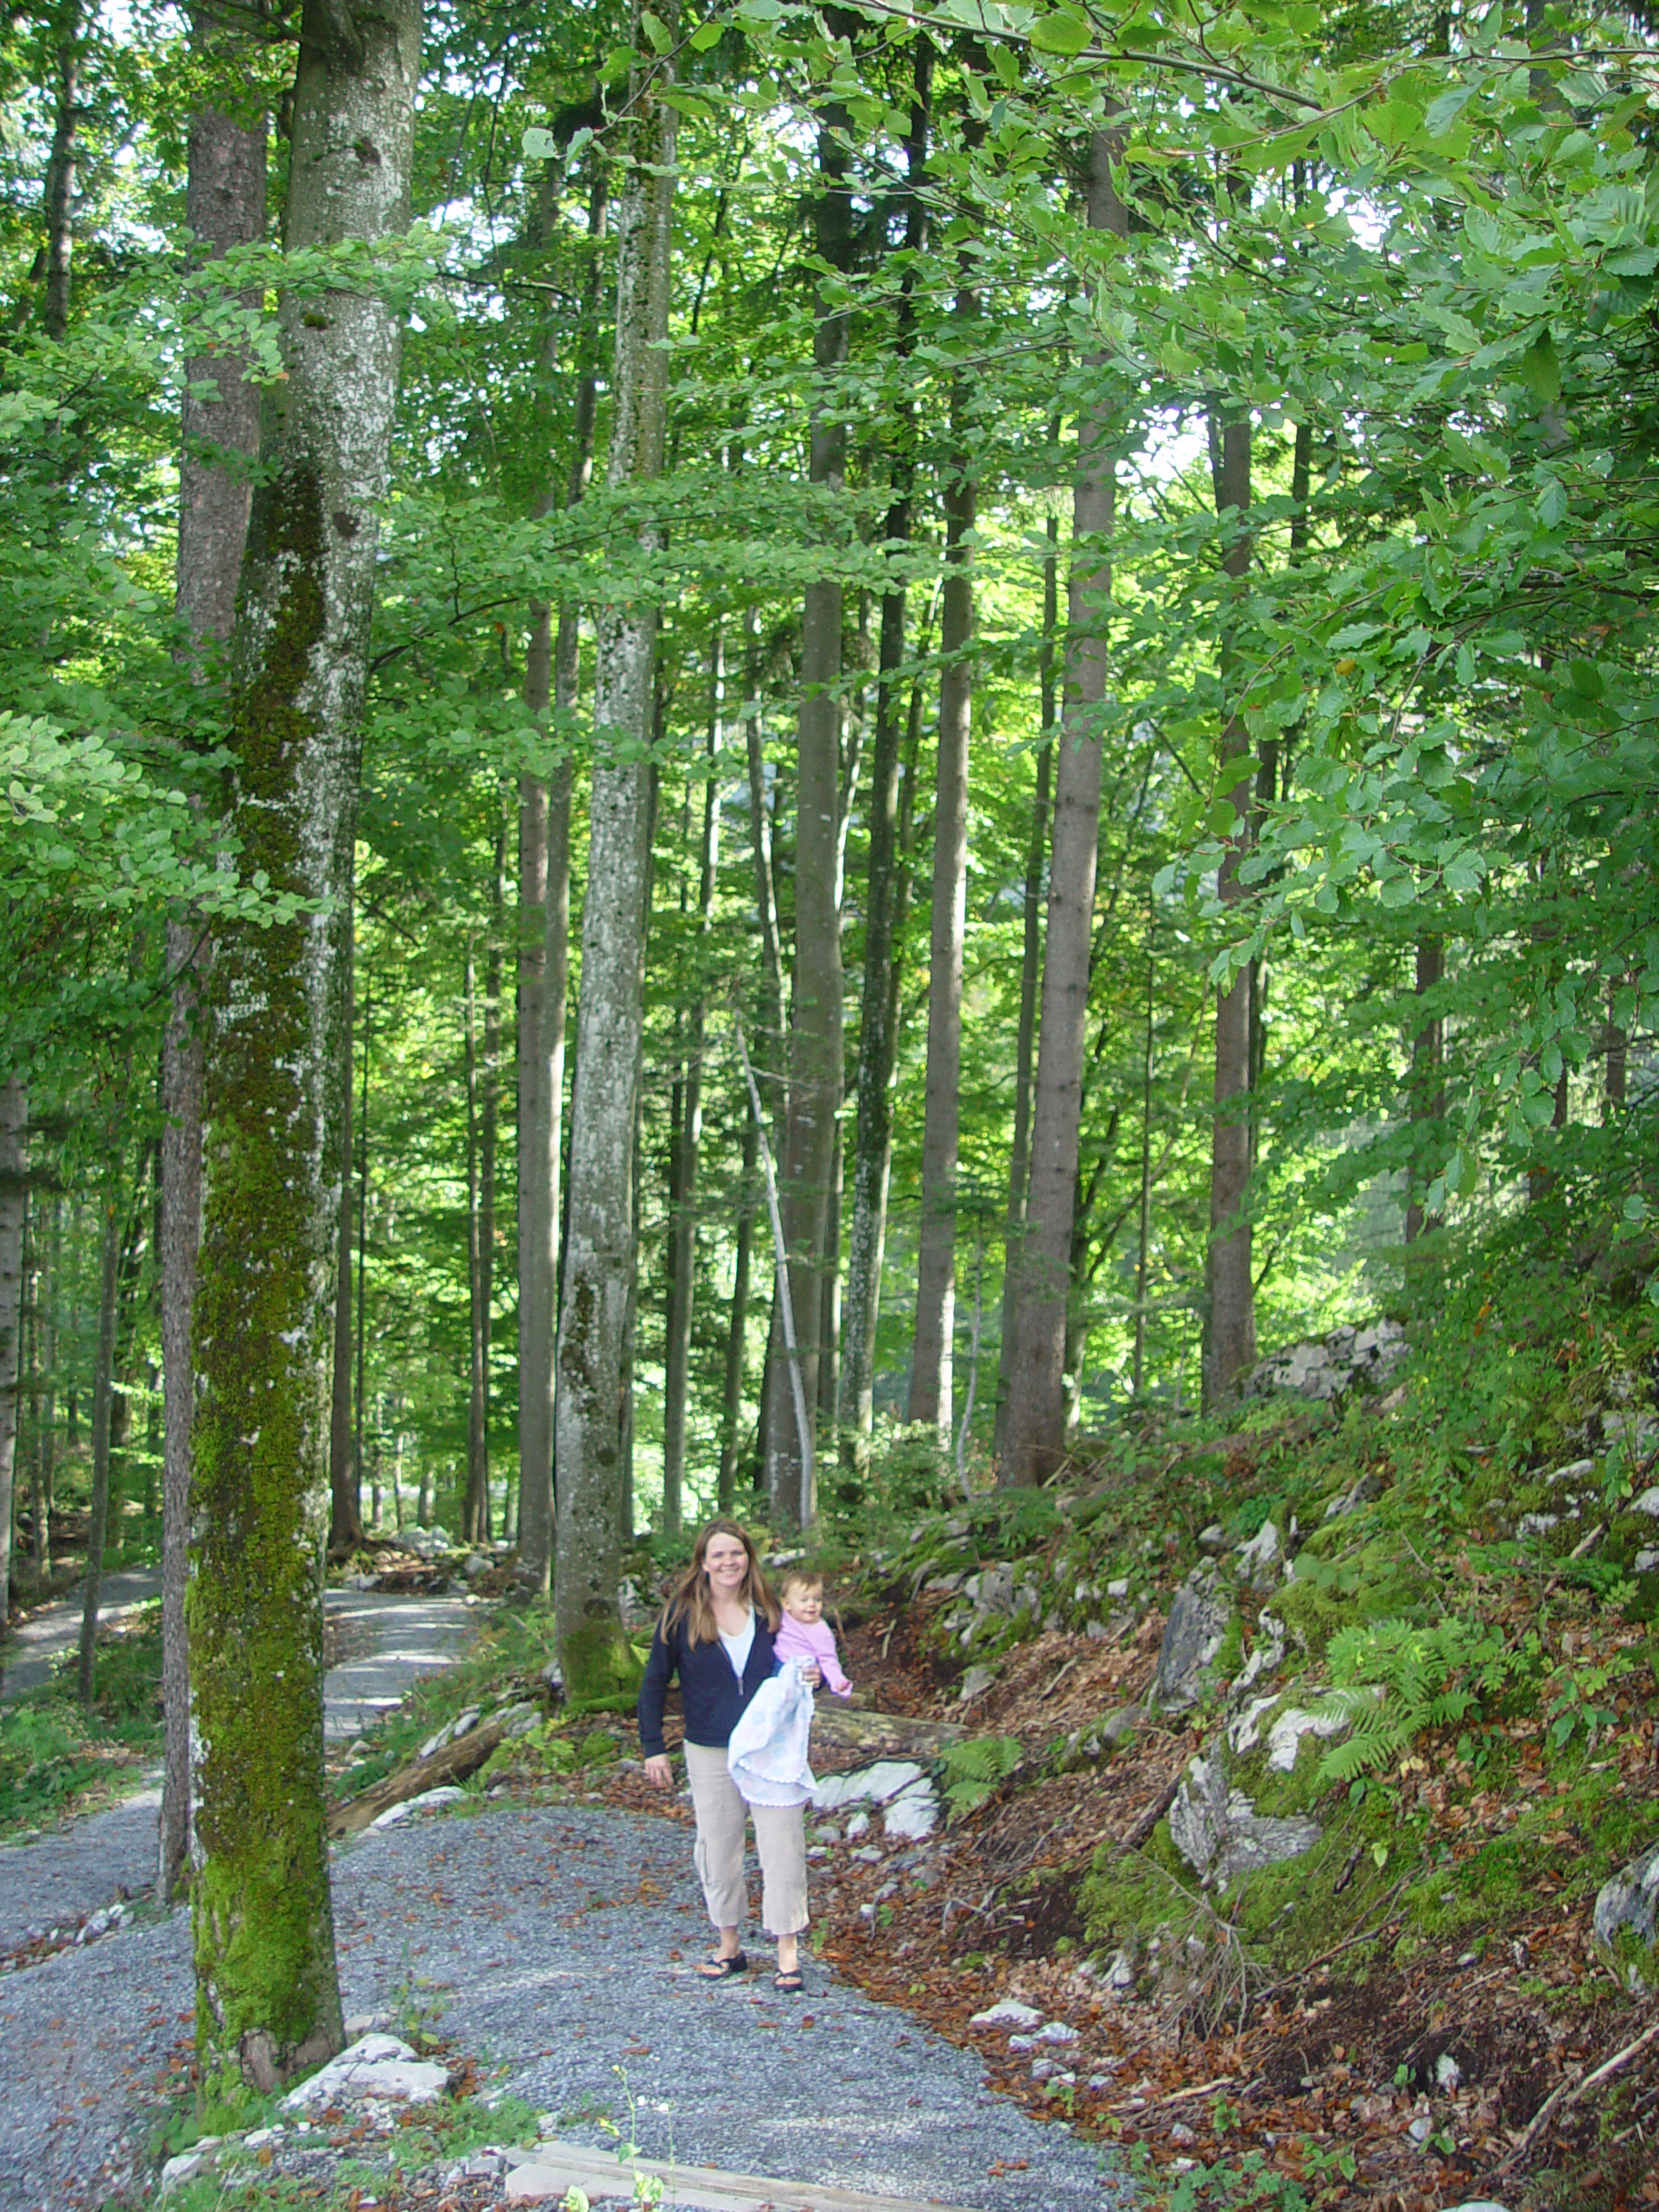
[841,38,933,1482]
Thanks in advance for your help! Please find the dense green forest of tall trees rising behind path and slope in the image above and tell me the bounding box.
[0,0,1659,2167]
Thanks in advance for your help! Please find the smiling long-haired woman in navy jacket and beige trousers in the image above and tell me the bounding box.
[639,1517,818,1991]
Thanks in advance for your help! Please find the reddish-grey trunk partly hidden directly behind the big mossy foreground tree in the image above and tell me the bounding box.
[157,86,265,1897]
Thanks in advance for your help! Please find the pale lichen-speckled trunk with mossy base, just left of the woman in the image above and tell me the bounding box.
[556,9,677,1697]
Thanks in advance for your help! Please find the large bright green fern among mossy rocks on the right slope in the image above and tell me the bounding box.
[1319,1612,1540,1783]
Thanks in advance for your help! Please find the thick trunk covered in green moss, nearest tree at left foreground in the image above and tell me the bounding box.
[188,0,420,2108]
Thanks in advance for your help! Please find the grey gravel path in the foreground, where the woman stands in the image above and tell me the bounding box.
[0,1805,1128,2212]
